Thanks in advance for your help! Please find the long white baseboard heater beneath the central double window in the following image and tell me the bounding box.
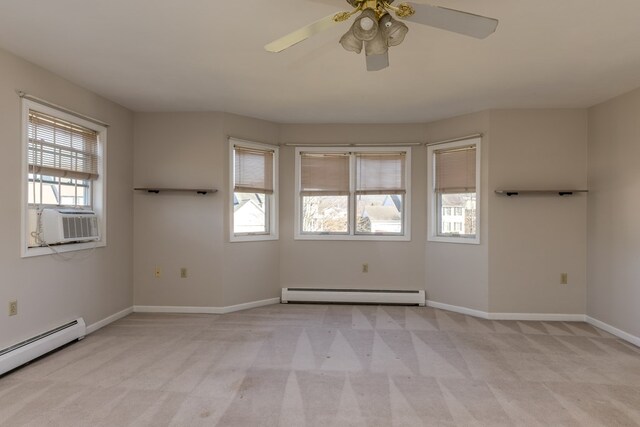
[280,288,425,306]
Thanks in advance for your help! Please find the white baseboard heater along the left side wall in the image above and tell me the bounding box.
[0,317,87,375]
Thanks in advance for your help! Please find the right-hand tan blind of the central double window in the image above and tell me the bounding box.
[356,152,406,194]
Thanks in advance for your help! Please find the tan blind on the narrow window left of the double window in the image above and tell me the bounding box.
[233,145,273,194]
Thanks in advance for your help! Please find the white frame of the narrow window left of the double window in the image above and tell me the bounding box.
[229,138,280,242]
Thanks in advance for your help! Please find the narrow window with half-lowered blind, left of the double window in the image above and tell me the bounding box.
[229,138,278,242]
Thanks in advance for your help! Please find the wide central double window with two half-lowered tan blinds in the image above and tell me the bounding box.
[296,147,411,240]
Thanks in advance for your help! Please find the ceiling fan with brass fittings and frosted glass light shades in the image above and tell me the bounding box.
[264,0,498,71]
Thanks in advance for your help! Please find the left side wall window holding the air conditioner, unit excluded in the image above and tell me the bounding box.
[22,99,107,256]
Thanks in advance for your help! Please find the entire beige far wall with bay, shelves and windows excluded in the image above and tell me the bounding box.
[134,110,586,314]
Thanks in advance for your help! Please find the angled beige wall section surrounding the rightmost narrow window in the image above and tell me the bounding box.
[424,112,491,311]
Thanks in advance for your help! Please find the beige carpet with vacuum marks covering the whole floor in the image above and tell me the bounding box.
[0,305,640,427]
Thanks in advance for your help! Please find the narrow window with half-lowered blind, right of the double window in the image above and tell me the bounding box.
[428,138,480,244]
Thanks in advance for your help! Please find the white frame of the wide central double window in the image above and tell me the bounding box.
[294,145,411,242]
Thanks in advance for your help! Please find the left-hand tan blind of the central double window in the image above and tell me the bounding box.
[300,153,349,195]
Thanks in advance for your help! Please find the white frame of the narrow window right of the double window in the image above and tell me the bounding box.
[427,138,482,245]
